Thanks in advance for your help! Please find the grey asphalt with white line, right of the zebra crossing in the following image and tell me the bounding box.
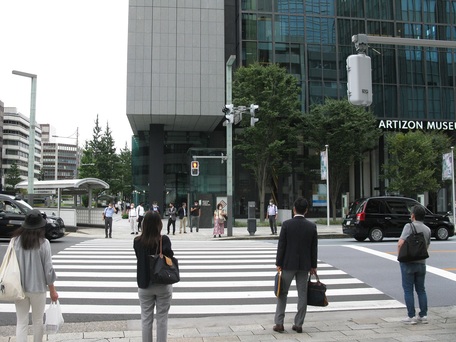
[319,238,456,306]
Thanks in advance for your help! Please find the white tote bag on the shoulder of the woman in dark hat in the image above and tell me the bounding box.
[0,238,25,302]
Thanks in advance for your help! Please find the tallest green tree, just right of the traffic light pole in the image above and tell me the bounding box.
[233,63,302,220]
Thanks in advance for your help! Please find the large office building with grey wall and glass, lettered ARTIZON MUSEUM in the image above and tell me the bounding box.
[127,0,456,213]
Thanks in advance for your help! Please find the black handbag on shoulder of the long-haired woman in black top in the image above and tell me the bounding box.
[149,236,180,284]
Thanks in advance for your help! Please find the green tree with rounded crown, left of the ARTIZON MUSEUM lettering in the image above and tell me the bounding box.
[303,99,381,220]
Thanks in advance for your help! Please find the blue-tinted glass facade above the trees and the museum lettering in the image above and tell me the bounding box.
[240,0,456,120]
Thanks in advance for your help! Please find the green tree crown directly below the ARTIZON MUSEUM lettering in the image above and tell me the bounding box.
[383,131,451,198]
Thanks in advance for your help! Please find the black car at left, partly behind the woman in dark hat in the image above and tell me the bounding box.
[0,194,65,240]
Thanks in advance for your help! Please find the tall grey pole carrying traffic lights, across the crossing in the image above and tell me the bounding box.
[225,55,236,236]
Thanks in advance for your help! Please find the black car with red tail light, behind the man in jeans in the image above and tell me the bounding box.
[342,196,454,242]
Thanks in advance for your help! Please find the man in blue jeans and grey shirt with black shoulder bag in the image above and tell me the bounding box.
[397,205,431,325]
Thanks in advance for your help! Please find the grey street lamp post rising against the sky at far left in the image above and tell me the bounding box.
[13,70,37,205]
